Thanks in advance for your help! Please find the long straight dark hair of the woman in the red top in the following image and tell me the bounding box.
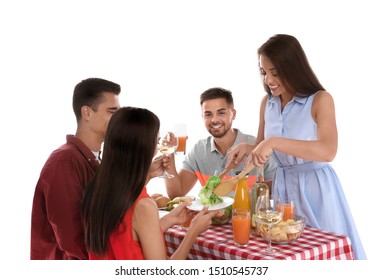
[83,107,160,256]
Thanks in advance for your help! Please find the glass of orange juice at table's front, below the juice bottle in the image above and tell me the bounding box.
[231,208,251,248]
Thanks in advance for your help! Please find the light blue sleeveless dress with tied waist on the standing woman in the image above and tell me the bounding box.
[265,94,366,259]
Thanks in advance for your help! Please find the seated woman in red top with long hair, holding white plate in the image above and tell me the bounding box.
[83,107,216,259]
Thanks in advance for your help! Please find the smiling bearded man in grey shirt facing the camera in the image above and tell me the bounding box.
[165,87,276,198]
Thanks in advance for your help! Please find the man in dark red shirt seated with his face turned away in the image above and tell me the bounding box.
[30,78,121,260]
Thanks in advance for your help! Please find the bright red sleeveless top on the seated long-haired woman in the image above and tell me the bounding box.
[89,187,165,260]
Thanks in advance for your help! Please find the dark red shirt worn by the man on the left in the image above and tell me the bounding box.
[31,135,98,260]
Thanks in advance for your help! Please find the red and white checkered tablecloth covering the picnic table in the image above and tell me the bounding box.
[165,223,354,260]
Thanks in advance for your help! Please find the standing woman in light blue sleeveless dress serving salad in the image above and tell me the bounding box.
[228,34,366,259]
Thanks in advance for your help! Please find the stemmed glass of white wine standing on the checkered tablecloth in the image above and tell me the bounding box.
[255,194,284,255]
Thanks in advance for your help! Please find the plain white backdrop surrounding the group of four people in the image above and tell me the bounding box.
[0,0,383,278]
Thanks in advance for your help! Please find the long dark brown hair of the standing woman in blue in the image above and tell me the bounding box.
[258,34,324,97]
